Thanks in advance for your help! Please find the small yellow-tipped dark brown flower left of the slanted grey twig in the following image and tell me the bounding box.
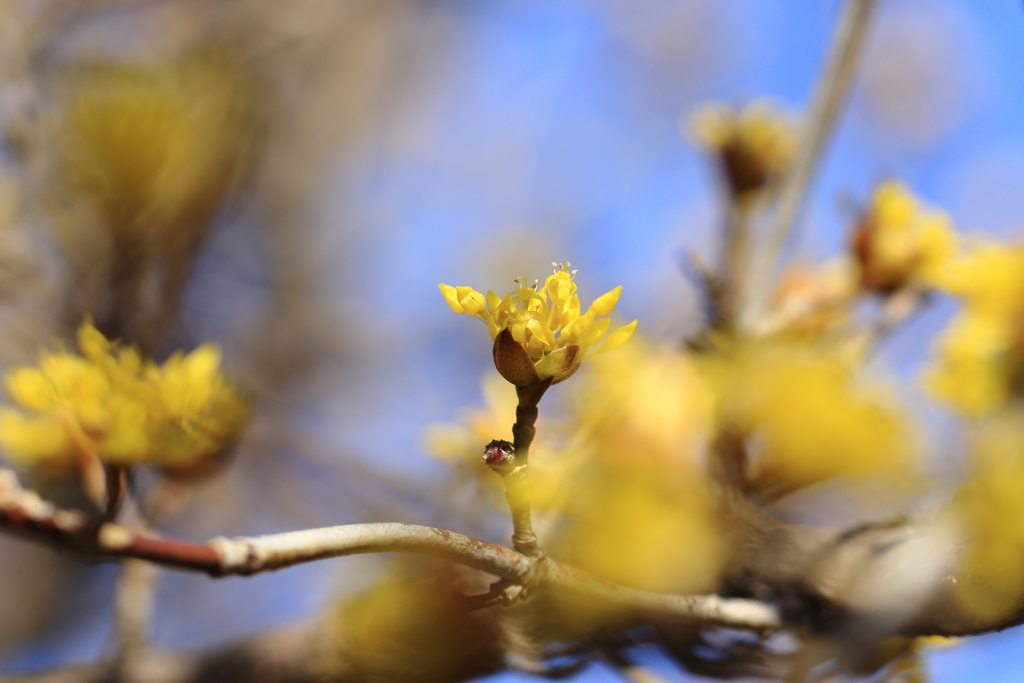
[690,100,797,197]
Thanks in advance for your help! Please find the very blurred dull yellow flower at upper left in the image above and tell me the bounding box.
[54,49,253,246]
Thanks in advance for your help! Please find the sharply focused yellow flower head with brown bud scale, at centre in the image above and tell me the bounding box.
[438,263,637,387]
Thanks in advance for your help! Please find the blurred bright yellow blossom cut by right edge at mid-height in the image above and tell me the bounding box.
[925,244,1024,415]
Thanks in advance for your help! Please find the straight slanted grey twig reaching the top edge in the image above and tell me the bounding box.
[741,0,878,327]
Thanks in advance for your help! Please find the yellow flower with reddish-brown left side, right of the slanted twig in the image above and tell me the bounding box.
[852,180,956,293]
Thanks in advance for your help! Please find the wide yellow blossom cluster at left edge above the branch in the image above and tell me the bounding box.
[0,323,249,469]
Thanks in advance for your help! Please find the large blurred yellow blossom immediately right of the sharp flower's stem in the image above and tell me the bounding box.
[552,339,726,593]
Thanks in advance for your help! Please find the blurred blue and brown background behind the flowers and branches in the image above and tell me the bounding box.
[0,0,1024,683]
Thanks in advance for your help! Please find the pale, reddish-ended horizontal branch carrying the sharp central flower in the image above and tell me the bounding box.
[0,469,782,631]
